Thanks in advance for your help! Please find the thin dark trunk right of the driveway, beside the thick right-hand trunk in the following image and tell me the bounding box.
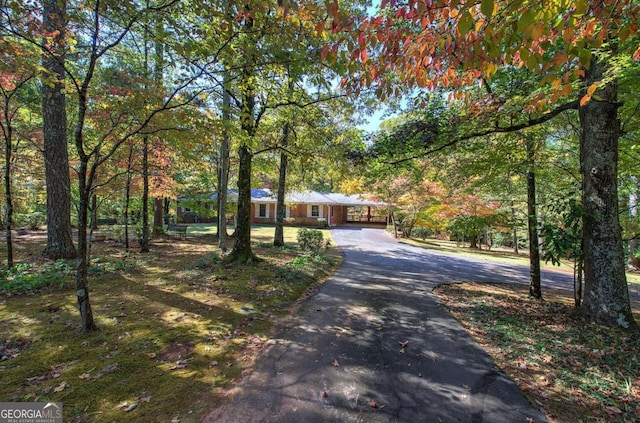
[526,136,542,300]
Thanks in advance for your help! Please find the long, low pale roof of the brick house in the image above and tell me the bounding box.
[211,188,384,207]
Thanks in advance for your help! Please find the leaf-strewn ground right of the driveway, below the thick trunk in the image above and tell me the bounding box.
[434,282,640,423]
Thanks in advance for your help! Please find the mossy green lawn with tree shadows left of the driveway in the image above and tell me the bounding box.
[0,225,341,423]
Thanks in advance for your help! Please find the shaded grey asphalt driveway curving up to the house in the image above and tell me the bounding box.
[205,228,572,423]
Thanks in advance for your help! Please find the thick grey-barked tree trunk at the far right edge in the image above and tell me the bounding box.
[579,56,637,328]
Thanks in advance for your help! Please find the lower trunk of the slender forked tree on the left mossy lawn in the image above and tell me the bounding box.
[76,161,98,333]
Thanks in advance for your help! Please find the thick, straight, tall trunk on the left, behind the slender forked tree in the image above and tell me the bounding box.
[42,0,76,259]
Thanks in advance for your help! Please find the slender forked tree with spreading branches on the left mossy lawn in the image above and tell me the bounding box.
[39,0,199,332]
